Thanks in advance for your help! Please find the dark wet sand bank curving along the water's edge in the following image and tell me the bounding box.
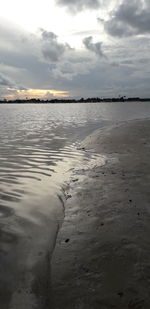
[51,120,150,309]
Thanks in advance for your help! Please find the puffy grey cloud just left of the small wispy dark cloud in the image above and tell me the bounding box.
[40,29,71,62]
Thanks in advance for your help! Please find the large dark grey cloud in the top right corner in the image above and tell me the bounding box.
[104,0,150,37]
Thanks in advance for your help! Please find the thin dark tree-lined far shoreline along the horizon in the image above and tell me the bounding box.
[0,97,150,104]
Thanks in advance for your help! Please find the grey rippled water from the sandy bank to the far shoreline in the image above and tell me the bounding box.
[0,103,150,309]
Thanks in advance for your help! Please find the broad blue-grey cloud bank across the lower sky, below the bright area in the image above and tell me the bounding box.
[0,18,150,97]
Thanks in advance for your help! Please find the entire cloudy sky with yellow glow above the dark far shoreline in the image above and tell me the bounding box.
[0,0,150,99]
